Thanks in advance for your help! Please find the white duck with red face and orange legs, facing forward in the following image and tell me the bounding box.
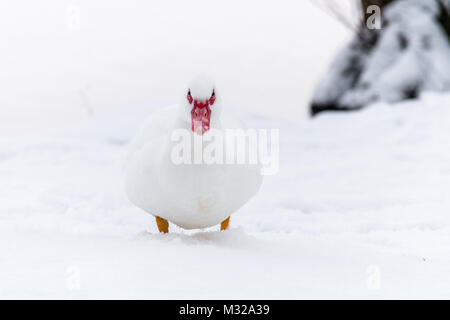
[125,76,262,233]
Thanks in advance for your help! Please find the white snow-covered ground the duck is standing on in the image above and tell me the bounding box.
[0,94,450,298]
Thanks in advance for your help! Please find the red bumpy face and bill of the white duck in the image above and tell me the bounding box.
[187,89,216,135]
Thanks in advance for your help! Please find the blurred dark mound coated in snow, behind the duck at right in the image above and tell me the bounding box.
[311,0,450,115]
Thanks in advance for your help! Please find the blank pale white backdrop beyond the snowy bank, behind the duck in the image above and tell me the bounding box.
[0,0,349,135]
